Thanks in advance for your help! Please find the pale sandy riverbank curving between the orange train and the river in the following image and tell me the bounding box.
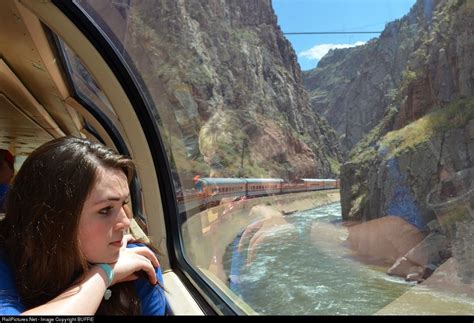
[182,190,340,282]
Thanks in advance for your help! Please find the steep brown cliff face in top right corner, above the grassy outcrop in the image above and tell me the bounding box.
[395,0,474,128]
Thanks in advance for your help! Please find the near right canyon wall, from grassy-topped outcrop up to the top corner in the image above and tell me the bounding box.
[341,0,474,230]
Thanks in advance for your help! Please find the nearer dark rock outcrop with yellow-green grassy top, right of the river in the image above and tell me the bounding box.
[341,99,474,230]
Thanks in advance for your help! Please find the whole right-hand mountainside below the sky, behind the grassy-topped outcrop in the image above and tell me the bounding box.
[303,0,474,156]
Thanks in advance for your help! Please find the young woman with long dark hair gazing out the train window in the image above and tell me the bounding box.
[0,137,166,315]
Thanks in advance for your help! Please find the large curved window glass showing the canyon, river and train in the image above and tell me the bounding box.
[71,0,474,315]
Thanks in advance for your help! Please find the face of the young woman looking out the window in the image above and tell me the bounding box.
[79,169,130,263]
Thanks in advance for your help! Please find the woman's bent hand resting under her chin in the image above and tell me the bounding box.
[110,235,160,285]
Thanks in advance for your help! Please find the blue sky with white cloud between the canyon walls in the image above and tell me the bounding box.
[272,0,416,71]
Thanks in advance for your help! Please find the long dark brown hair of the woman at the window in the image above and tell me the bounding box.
[0,136,149,314]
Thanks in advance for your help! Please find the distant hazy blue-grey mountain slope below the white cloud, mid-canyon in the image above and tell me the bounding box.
[303,37,410,152]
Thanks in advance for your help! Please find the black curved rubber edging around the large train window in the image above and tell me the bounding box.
[51,0,245,315]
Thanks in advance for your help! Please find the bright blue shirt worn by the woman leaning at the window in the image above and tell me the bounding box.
[0,244,167,315]
